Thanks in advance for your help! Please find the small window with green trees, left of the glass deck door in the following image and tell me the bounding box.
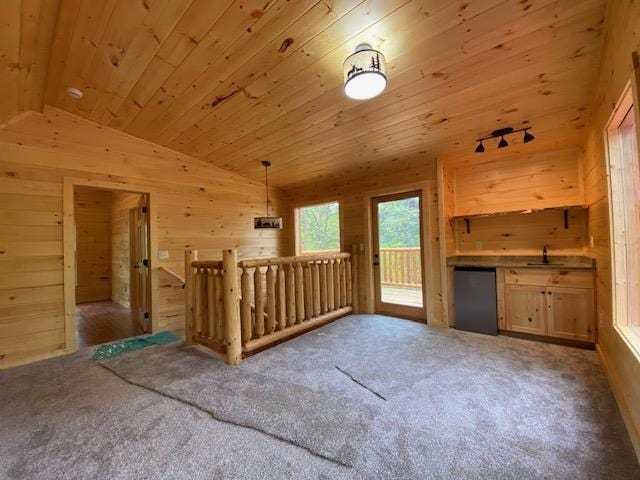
[296,202,340,255]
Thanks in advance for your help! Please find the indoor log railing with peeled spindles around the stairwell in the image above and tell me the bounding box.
[185,250,358,365]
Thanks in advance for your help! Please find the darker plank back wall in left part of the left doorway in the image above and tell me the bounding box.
[73,187,111,303]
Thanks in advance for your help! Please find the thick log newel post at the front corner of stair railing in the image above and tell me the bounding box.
[222,249,242,365]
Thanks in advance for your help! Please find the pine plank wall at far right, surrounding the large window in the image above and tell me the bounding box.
[583,0,640,458]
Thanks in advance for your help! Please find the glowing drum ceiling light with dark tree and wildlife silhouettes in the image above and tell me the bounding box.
[342,43,387,100]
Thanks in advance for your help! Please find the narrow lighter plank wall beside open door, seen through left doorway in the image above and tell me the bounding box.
[110,191,142,308]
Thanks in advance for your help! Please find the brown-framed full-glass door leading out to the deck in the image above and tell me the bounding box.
[372,191,427,321]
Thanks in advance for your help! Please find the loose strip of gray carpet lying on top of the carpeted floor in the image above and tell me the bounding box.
[101,346,376,467]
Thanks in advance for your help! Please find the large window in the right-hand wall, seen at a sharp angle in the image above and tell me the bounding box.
[607,81,640,351]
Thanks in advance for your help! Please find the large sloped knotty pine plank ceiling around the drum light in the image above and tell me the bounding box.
[2,0,606,188]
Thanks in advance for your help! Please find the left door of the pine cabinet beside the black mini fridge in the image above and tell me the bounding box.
[504,285,547,335]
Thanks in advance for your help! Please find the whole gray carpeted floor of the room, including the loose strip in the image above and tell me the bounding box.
[0,315,640,479]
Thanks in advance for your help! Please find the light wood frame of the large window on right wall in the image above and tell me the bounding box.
[604,78,640,358]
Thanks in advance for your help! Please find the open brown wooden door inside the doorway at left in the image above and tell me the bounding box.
[129,195,151,332]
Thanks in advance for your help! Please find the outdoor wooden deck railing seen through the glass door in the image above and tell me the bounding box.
[380,247,422,287]
